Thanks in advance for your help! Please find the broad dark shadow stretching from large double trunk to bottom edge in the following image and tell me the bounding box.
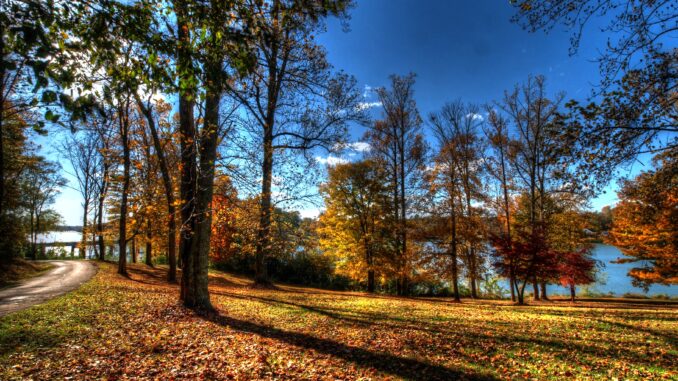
[205,313,497,380]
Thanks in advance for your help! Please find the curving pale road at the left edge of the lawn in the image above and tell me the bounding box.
[0,261,97,316]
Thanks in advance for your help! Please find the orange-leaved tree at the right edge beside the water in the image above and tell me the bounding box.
[609,150,678,289]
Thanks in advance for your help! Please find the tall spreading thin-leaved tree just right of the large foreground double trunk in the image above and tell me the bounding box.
[230,0,363,285]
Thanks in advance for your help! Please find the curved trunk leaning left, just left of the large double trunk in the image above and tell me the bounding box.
[136,95,177,283]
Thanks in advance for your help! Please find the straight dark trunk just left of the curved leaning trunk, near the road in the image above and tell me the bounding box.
[118,105,131,276]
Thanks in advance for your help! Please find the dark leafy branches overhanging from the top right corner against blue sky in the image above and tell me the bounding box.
[513,0,678,184]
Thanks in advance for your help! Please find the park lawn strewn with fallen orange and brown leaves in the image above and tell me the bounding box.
[0,263,678,380]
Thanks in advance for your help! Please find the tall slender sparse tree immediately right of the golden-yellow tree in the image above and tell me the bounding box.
[366,74,427,295]
